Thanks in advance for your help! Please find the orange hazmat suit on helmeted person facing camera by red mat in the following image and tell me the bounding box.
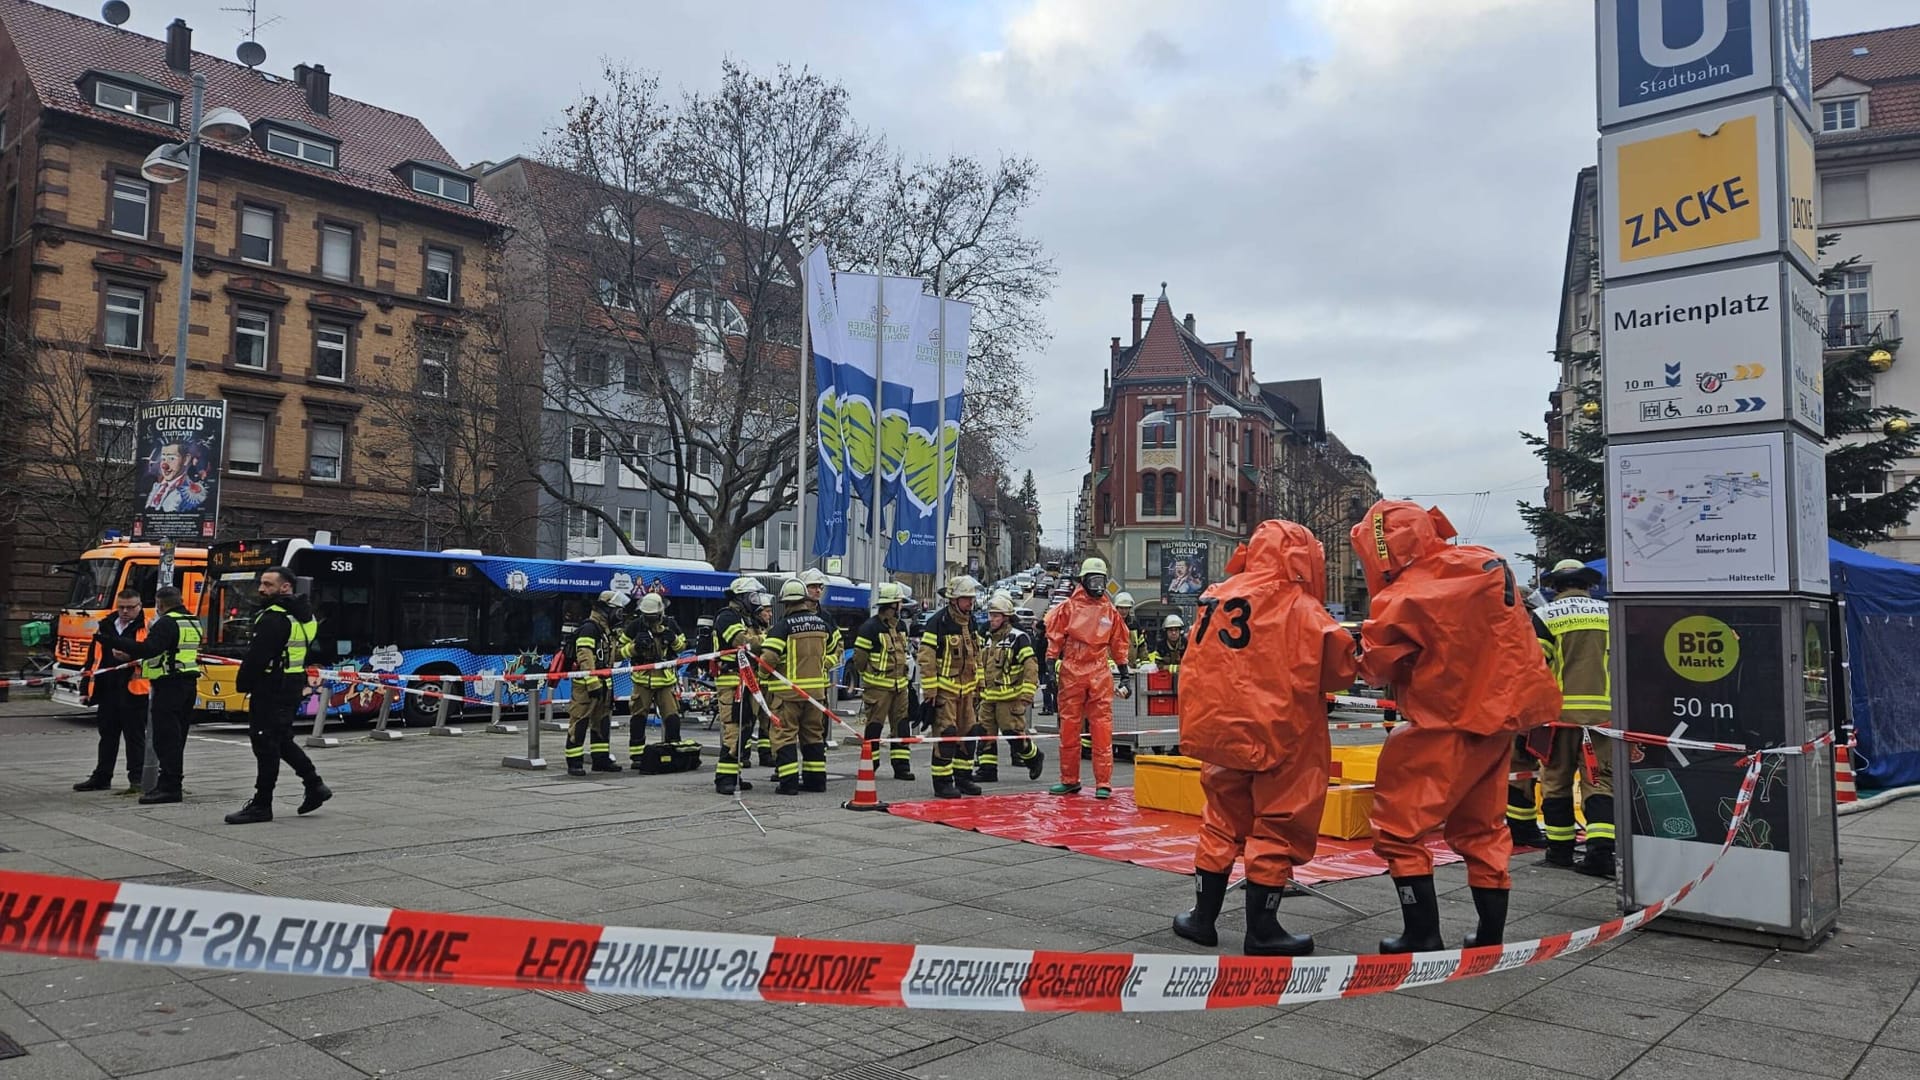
[1046,588,1129,788]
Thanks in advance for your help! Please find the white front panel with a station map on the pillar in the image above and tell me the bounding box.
[1607,434,1789,594]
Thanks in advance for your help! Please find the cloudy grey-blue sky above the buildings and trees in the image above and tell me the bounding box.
[60,0,1920,564]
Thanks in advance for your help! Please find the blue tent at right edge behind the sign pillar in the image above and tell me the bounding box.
[1588,540,1920,788]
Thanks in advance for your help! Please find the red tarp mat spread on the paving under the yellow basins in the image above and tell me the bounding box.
[889,788,1459,886]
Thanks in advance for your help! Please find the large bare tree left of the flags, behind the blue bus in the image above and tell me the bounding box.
[530,63,877,567]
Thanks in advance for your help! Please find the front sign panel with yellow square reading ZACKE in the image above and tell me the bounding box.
[1615,115,1770,263]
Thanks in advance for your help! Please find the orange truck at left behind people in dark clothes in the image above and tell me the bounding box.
[52,540,207,705]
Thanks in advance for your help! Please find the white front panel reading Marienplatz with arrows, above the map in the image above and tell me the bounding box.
[1601,263,1791,434]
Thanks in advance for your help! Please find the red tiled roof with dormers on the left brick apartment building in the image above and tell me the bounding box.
[0,0,499,223]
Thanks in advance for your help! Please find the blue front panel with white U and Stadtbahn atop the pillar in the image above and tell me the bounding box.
[1596,0,1772,127]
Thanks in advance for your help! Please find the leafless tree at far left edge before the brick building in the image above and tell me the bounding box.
[0,325,159,552]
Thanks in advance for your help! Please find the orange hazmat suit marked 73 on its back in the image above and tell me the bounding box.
[1179,521,1356,888]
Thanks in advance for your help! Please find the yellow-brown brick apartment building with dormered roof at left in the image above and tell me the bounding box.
[0,0,501,634]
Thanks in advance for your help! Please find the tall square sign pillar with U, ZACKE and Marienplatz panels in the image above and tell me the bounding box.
[1596,0,1839,947]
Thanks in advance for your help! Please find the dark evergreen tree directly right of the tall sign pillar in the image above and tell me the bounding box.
[1820,244,1920,546]
